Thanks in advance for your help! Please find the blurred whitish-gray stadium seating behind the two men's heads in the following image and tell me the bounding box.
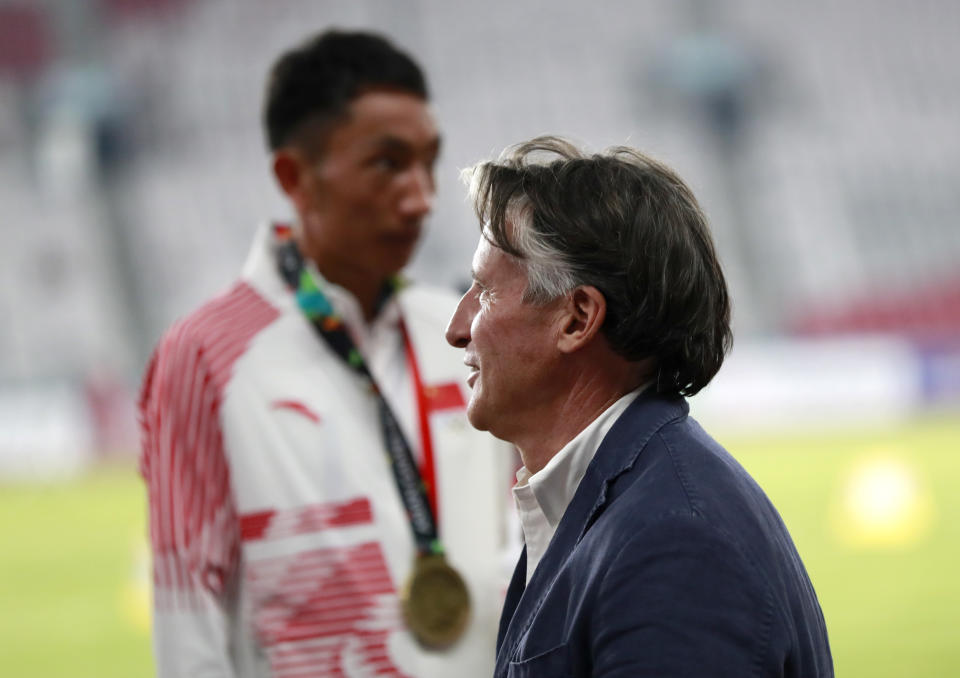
[0,0,960,379]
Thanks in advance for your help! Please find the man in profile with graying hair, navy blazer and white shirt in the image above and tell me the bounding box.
[447,137,833,678]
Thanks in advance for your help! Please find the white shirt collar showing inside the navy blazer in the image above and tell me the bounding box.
[513,386,645,584]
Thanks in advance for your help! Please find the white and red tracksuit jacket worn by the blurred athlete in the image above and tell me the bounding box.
[140,228,513,678]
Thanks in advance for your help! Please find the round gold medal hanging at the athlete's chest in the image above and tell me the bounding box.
[401,554,470,650]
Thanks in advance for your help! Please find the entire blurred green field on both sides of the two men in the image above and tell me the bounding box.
[0,417,960,678]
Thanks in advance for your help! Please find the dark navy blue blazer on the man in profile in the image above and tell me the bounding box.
[495,393,833,678]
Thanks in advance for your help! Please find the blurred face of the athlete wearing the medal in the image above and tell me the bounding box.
[287,91,440,281]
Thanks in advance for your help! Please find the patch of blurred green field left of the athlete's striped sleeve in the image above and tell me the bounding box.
[0,465,153,678]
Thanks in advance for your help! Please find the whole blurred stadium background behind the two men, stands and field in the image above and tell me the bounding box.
[0,0,960,677]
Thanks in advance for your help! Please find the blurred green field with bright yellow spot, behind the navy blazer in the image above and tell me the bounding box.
[723,416,960,678]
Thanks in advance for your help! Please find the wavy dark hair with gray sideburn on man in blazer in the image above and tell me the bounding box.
[461,136,733,395]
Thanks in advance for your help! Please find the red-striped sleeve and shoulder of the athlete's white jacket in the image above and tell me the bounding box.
[139,283,278,604]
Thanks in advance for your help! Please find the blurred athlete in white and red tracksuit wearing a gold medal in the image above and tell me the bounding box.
[140,31,510,678]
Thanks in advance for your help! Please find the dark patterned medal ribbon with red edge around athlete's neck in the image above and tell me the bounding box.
[274,227,443,555]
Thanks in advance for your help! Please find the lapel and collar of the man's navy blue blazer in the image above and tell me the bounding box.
[497,389,689,667]
